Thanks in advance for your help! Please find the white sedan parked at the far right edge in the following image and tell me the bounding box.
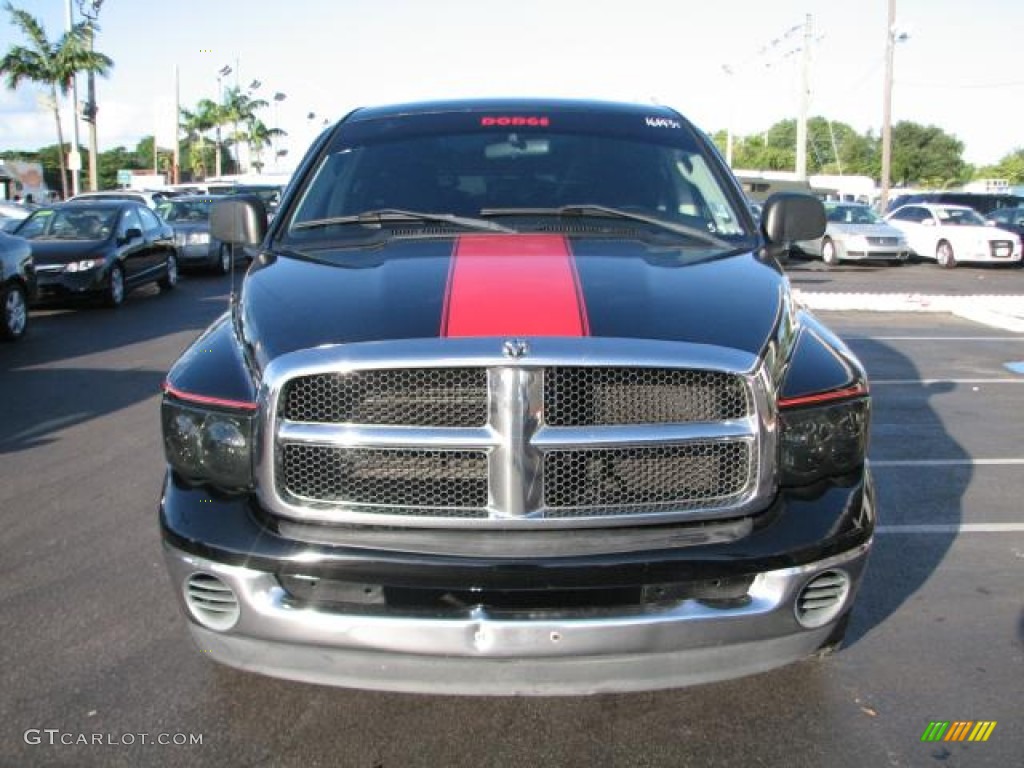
[886,203,1021,268]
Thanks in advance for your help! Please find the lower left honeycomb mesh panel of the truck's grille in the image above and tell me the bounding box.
[283,445,487,516]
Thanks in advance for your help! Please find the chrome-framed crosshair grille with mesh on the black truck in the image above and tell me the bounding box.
[268,338,775,529]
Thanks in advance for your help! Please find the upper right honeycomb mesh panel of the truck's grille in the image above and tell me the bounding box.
[544,368,751,427]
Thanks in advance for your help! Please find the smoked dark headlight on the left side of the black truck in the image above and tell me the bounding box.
[161,395,254,490]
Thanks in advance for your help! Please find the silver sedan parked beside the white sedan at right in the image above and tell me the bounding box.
[797,202,910,264]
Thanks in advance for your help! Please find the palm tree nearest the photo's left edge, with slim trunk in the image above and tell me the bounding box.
[0,2,114,198]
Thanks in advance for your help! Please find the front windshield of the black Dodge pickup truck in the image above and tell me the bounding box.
[287,125,752,250]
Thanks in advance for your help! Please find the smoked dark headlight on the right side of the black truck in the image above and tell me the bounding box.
[779,397,870,485]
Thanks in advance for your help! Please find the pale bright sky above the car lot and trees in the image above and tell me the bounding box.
[0,0,1024,170]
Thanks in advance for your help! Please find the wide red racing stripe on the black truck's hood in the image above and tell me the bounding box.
[441,234,590,337]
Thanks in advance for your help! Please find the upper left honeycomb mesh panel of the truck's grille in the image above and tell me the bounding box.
[284,368,487,427]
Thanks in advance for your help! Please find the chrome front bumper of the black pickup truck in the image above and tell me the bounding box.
[164,542,870,695]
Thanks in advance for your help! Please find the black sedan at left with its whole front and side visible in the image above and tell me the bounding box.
[15,200,178,306]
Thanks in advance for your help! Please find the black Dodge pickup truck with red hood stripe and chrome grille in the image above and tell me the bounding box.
[160,99,876,694]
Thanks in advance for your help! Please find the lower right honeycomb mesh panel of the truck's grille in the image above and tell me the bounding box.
[544,442,752,516]
